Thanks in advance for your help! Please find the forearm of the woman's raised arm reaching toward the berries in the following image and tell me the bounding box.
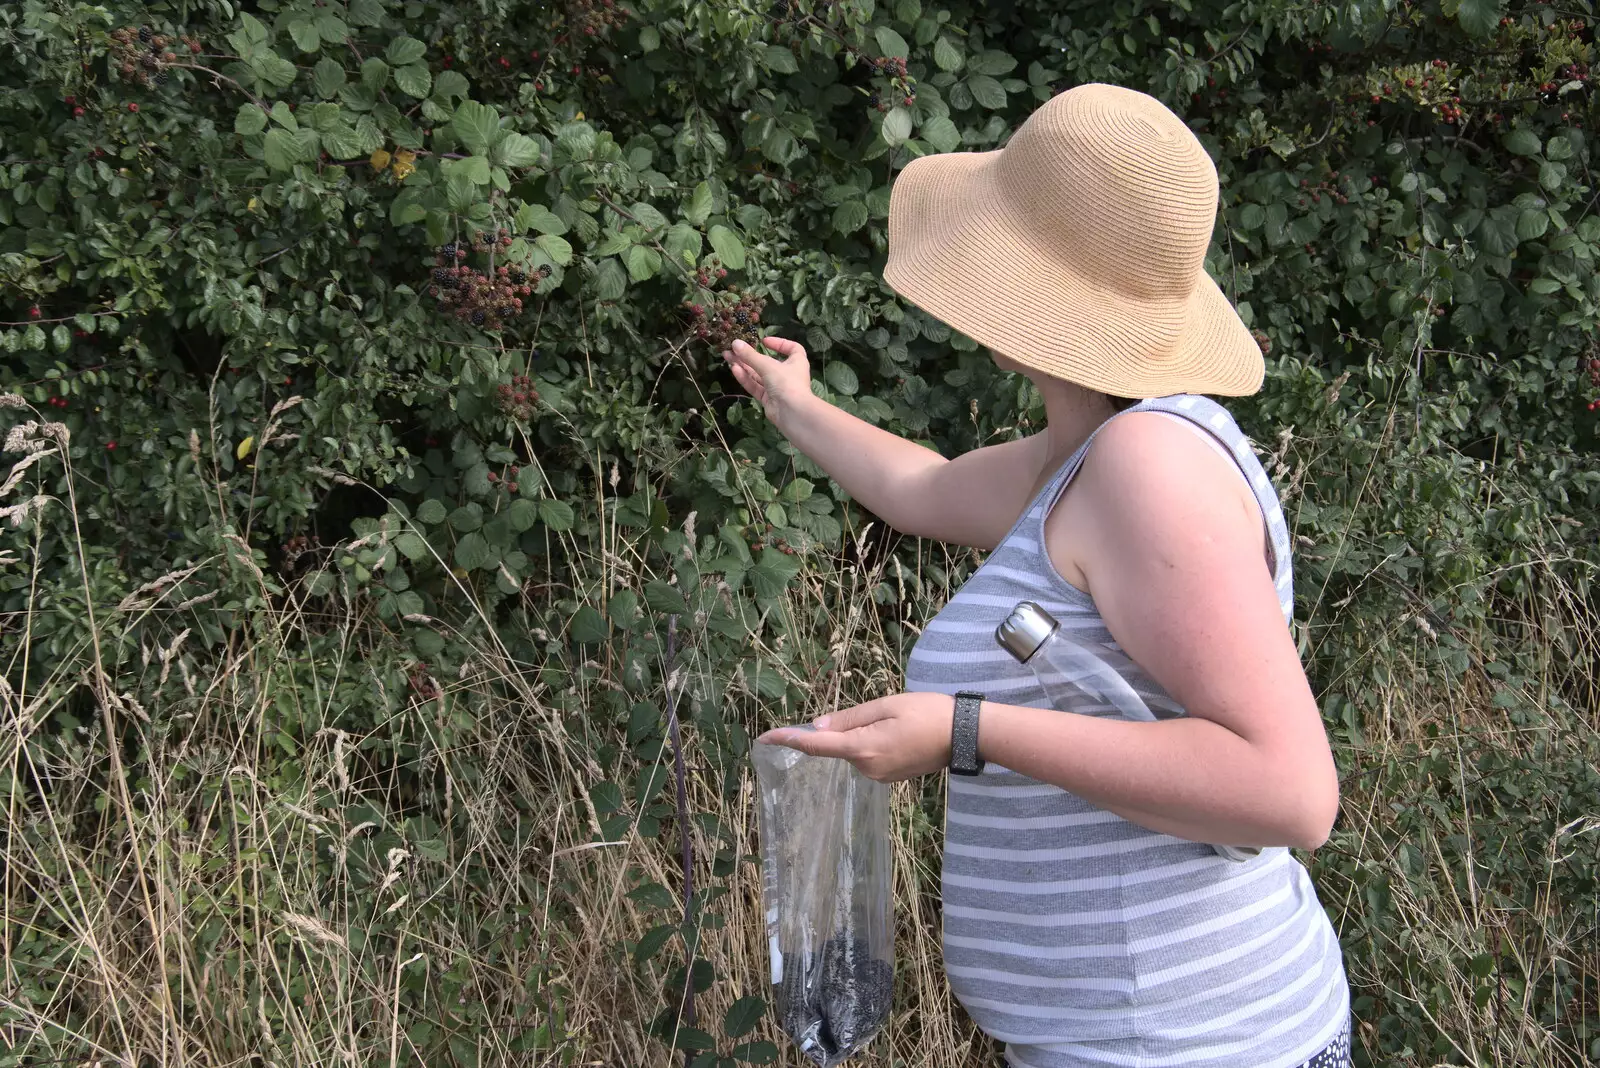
[778,397,949,534]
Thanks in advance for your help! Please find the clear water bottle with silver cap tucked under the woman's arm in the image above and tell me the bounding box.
[995,601,1261,860]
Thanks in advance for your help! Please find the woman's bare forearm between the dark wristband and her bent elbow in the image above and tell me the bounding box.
[978,700,1338,849]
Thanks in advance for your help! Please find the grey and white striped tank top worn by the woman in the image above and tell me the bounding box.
[906,395,1350,1068]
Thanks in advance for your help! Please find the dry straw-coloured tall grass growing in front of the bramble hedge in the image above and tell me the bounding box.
[0,406,1600,1068]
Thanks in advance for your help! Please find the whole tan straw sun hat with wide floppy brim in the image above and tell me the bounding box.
[883,85,1264,398]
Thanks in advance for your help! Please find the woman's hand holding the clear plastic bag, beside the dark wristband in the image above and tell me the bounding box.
[755,694,955,782]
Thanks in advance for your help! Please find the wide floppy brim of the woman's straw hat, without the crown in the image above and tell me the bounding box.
[883,149,1266,398]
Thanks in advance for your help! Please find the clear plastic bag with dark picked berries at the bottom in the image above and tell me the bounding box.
[750,743,894,1068]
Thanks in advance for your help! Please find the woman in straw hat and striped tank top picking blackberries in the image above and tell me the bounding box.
[725,85,1349,1068]
